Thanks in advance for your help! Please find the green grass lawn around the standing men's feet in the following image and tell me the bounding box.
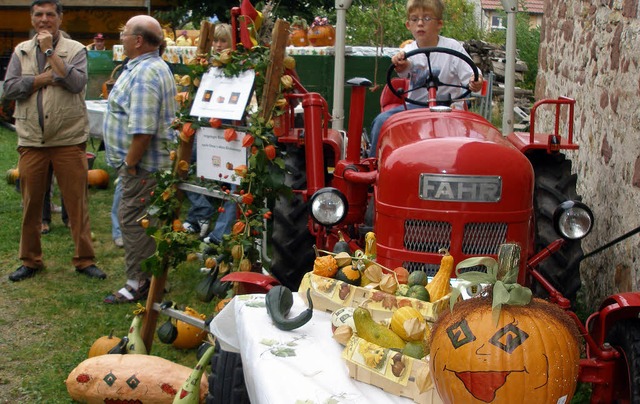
[0,126,214,403]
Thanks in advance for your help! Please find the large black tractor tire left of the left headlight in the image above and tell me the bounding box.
[270,145,315,291]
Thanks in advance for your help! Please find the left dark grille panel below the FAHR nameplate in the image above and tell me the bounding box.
[404,219,451,252]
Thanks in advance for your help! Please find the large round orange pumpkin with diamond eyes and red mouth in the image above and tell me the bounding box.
[430,298,580,403]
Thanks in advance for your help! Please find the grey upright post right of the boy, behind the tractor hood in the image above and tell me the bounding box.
[501,0,518,136]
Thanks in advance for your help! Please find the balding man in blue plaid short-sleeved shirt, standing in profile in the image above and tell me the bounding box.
[103,15,176,304]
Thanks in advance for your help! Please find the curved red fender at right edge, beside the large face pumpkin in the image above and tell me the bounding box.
[586,292,640,346]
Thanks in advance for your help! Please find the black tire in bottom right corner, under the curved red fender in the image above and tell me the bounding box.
[607,320,640,404]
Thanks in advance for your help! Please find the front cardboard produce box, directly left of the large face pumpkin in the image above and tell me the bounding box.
[342,335,442,404]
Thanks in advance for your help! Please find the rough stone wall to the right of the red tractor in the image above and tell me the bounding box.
[536,0,640,309]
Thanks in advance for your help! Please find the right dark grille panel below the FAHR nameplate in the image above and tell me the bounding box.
[462,223,507,255]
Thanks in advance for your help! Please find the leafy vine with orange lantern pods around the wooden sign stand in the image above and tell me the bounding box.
[141,41,293,286]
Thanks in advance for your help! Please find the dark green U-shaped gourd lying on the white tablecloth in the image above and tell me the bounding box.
[264,285,313,331]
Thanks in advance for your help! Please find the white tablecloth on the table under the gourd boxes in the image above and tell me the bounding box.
[211,294,413,404]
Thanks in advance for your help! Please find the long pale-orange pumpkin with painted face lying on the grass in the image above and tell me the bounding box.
[65,355,209,404]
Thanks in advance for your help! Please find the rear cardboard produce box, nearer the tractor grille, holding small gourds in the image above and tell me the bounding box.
[298,272,449,322]
